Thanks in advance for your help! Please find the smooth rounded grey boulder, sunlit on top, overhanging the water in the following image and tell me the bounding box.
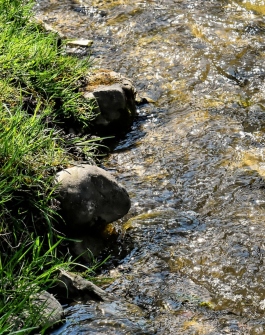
[56,164,131,233]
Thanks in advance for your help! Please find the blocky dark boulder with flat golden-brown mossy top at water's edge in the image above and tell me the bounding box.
[80,70,136,135]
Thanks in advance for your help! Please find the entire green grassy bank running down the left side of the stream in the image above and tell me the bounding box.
[0,0,99,334]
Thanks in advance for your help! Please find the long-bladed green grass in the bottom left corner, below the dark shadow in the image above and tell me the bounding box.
[0,238,71,335]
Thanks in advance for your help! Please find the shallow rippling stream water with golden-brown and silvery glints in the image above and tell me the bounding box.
[37,0,265,335]
